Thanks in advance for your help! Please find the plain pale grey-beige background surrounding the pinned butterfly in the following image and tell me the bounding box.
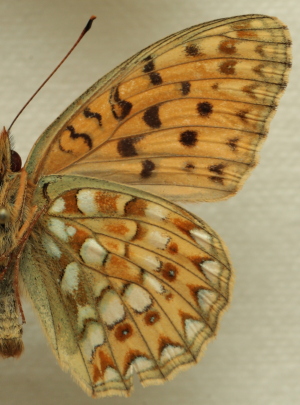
[0,0,300,405]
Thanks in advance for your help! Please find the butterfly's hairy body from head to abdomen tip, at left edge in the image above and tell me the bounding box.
[0,130,26,357]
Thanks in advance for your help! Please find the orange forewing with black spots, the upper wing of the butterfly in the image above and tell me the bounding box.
[27,15,290,201]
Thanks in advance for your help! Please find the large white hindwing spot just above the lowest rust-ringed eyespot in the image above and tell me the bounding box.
[98,290,125,326]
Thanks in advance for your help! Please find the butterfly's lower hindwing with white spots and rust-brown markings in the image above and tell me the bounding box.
[21,176,231,396]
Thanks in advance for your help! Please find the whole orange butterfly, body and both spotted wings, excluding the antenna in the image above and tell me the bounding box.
[0,15,291,397]
